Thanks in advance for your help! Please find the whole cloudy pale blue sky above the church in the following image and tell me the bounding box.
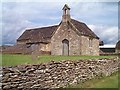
[0,0,118,45]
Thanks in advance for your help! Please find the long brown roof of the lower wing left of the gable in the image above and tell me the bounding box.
[17,25,58,43]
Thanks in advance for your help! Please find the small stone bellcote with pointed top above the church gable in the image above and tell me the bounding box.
[62,4,70,22]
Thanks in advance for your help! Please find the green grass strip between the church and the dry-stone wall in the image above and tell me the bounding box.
[2,54,113,66]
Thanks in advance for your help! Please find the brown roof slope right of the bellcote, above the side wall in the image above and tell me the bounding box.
[71,19,99,39]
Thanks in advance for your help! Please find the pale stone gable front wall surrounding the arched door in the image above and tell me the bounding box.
[51,22,80,55]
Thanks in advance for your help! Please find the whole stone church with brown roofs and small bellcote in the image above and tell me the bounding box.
[17,4,100,55]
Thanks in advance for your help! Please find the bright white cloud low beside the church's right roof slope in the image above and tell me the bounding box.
[88,25,118,44]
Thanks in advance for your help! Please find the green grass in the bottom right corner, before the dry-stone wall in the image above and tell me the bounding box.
[68,72,120,88]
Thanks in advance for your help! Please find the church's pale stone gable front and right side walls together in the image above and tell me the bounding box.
[51,22,99,55]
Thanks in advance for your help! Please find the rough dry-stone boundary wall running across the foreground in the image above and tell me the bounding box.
[2,59,119,90]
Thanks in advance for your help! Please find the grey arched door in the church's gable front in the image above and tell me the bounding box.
[62,39,69,56]
